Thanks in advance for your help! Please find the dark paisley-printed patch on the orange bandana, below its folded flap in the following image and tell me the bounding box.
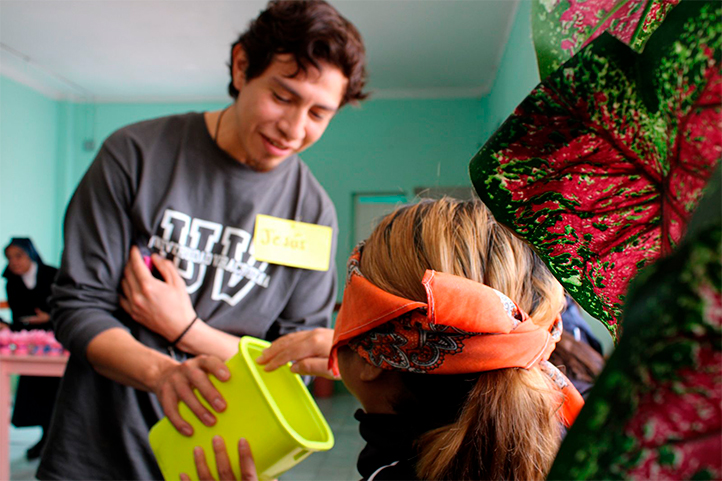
[349,313,473,373]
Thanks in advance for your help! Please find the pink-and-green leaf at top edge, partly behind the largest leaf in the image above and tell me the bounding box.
[532,0,679,79]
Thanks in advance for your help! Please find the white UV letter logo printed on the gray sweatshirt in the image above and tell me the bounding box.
[148,209,271,306]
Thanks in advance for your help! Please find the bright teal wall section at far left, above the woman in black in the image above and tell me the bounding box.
[0,77,61,292]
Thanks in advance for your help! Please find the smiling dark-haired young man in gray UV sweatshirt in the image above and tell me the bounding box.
[37,1,365,479]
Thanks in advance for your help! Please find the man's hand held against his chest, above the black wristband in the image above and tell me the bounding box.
[120,246,196,341]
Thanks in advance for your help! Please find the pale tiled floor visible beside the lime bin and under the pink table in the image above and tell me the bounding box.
[10,392,364,481]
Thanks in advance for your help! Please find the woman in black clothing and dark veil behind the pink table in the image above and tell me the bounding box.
[3,237,60,459]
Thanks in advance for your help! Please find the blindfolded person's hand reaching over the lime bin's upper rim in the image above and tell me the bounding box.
[256,327,340,380]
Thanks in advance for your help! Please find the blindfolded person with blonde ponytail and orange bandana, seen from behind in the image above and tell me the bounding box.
[196,199,583,480]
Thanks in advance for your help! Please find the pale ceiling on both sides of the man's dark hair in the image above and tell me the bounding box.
[0,0,518,102]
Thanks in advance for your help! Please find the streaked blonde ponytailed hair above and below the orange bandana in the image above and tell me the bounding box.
[360,198,564,480]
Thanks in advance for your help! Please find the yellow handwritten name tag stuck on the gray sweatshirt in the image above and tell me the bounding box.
[253,214,333,271]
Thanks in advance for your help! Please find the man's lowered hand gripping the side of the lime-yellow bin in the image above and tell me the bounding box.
[153,356,231,436]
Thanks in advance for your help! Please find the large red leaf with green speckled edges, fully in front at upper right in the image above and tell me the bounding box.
[470,2,722,337]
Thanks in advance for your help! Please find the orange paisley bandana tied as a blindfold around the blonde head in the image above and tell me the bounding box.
[329,248,584,425]
